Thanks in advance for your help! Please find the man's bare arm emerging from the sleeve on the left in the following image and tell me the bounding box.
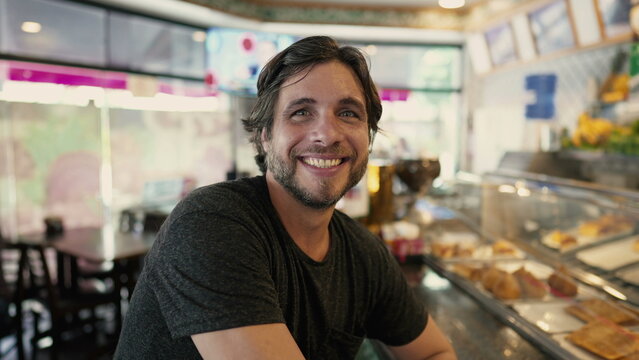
[191,323,304,360]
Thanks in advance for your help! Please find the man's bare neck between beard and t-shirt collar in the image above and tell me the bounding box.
[266,172,335,261]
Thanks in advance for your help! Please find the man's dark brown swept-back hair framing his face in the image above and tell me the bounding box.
[242,36,382,173]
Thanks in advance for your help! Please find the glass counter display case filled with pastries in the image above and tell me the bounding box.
[414,171,639,359]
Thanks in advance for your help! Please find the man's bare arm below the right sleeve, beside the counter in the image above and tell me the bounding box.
[388,315,457,360]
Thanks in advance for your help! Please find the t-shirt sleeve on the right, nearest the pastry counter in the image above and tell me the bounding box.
[367,236,428,346]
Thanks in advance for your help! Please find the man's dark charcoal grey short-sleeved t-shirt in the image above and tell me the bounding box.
[115,176,427,359]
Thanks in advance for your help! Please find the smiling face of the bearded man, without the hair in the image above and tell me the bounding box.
[262,61,368,209]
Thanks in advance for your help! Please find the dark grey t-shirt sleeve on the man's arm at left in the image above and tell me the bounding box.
[149,211,284,338]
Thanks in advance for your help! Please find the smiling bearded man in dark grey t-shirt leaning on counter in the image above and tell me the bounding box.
[115,36,456,360]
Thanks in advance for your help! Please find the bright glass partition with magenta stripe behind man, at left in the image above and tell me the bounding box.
[0,61,233,236]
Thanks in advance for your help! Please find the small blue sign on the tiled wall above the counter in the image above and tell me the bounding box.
[526,74,557,120]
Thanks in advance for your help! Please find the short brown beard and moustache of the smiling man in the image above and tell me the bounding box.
[266,148,368,210]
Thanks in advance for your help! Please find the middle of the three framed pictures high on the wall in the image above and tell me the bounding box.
[528,0,575,55]
